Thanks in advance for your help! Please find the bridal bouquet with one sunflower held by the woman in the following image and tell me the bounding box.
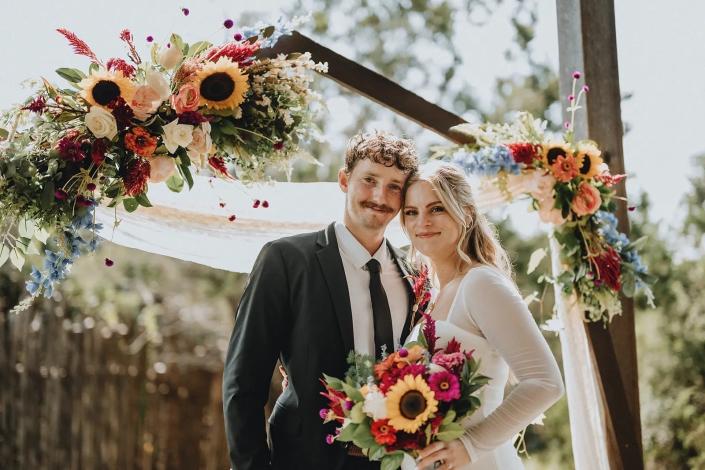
[320,313,489,470]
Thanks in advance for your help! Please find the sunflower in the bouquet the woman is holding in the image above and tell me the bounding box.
[387,375,438,433]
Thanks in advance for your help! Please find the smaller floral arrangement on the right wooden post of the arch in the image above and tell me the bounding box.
[434,72,653,322]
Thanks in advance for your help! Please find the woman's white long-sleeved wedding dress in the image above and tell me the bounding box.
[402,266,563,470]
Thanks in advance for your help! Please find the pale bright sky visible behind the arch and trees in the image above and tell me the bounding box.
[0,0,705,253]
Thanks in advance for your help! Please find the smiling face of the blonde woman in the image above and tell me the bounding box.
[402,181,460,260]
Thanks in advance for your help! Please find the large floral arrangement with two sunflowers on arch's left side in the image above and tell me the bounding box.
[0,15,327,297]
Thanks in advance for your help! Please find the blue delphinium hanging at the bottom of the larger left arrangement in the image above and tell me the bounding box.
[26,208,103,298]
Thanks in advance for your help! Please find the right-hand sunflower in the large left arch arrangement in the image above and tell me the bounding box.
[194,57,250,109]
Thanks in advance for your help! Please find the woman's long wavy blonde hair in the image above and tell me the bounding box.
[401,163,513,279]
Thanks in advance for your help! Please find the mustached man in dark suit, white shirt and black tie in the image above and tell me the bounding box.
[223,132,418,470]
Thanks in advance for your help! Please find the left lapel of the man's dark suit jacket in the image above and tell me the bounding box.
[316,223,355,351]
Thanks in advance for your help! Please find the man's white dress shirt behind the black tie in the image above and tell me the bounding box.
[335,222,409,355]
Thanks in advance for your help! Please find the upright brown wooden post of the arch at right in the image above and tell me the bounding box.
[556,0,644,470]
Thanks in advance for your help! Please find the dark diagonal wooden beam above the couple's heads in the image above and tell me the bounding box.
[258,31,467,144]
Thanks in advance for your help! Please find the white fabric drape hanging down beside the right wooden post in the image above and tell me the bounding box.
[550,237,610,470]
